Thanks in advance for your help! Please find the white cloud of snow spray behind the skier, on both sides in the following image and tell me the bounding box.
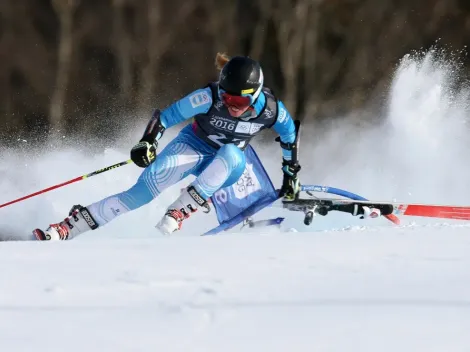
[0,50,470,237]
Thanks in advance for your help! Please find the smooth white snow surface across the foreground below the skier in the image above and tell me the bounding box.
[0,225,470,352]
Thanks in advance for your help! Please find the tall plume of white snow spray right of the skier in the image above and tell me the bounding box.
[302,51,470,204]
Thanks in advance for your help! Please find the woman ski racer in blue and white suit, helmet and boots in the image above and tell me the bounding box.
[33,53,300,240]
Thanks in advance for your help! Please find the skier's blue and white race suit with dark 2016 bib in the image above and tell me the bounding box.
[87,83,296,226]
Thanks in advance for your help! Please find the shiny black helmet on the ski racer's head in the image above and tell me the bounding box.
[219,56,264,101]
